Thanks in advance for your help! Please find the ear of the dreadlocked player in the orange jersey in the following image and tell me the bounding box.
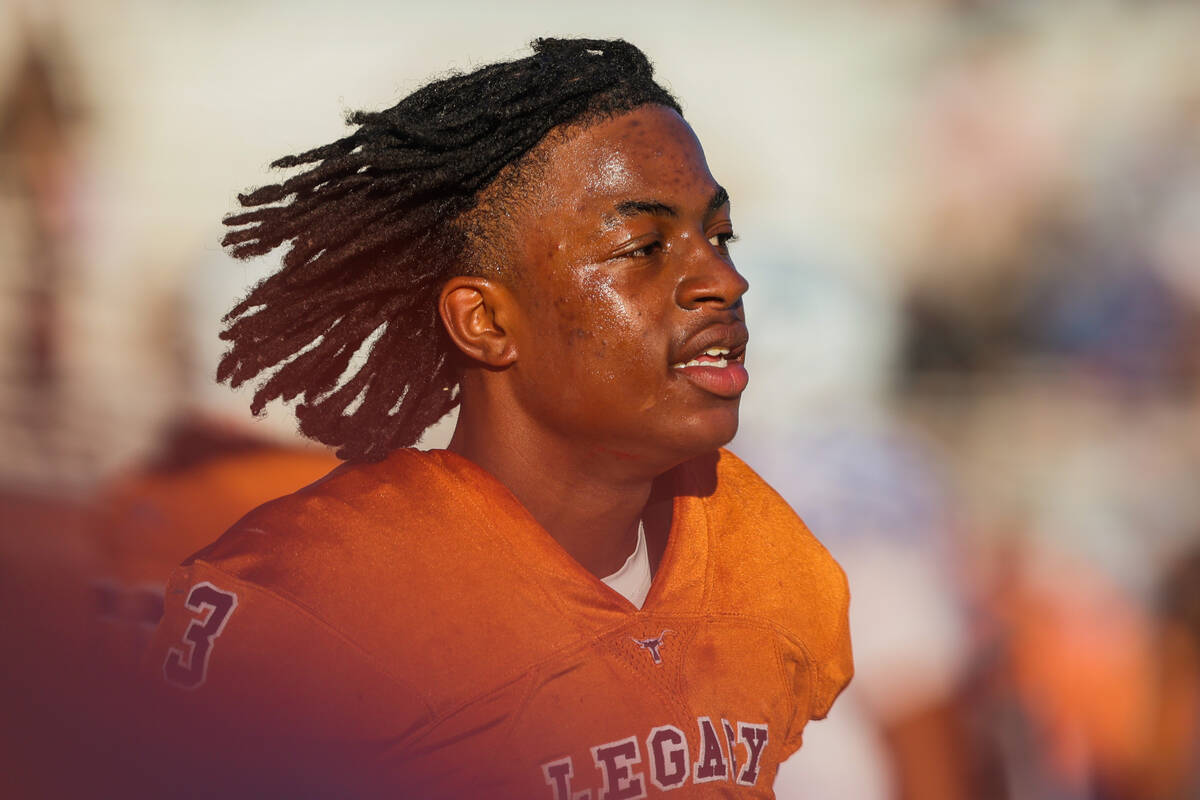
[438,275,517,367]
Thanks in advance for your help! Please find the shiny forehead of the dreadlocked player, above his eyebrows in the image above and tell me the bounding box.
[538,106,716,219]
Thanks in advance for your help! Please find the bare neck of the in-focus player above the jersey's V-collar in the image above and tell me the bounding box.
[448,393,670,577]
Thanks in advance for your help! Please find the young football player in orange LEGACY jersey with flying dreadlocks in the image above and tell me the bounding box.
[149,40,851,800]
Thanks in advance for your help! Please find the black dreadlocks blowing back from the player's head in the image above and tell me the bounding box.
[217,38,680,461]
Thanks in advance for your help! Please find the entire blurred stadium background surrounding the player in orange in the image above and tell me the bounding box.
[0,0,1200,800]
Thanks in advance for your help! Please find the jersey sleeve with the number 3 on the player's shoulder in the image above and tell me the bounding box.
[142,561,431,795]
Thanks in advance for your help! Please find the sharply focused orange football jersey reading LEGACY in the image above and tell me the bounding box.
[146,450,852,800]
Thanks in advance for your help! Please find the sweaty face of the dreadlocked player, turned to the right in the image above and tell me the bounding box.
[509,106,748,465]
